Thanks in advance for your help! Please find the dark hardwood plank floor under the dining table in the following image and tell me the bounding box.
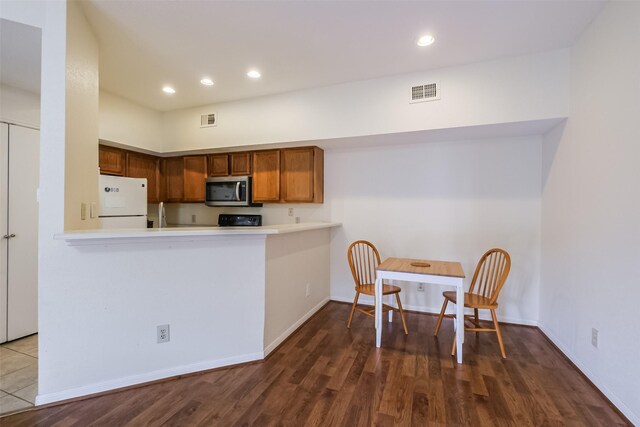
[0,303,626,426]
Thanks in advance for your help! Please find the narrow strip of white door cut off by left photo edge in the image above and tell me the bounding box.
[0,123,9,343]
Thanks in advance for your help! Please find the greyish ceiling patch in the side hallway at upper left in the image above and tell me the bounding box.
[0,19,42,93]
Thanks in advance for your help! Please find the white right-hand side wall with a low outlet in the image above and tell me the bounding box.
[540,2,640,425]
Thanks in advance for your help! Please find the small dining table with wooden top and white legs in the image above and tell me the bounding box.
[375,258,464,363]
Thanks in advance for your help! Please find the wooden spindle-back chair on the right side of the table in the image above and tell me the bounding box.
[433,248,511,358]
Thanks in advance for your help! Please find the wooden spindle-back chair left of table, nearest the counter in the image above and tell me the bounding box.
[347,240,409,334]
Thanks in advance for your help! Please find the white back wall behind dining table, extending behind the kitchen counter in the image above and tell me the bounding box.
[167,135,541,324]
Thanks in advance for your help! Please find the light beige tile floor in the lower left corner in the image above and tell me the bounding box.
[0,334,38,414]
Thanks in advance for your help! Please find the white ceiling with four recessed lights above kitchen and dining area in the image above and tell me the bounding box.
[83,0,604,111]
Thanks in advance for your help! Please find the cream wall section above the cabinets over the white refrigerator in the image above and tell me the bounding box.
[99,91,164,153]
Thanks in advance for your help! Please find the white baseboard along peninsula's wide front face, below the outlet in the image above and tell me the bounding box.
[36,352,264,405]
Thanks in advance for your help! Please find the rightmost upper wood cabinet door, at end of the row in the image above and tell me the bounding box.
[280,147,324,203]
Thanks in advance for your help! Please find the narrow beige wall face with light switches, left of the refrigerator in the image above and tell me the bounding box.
[64,1,99,230]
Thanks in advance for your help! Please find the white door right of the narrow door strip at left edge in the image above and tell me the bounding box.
[4,126,40,340]
